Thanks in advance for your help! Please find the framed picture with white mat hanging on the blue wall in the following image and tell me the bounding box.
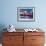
[17,7,35,22]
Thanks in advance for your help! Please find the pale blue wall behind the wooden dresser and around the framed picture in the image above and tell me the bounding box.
[0,0,46,43]
